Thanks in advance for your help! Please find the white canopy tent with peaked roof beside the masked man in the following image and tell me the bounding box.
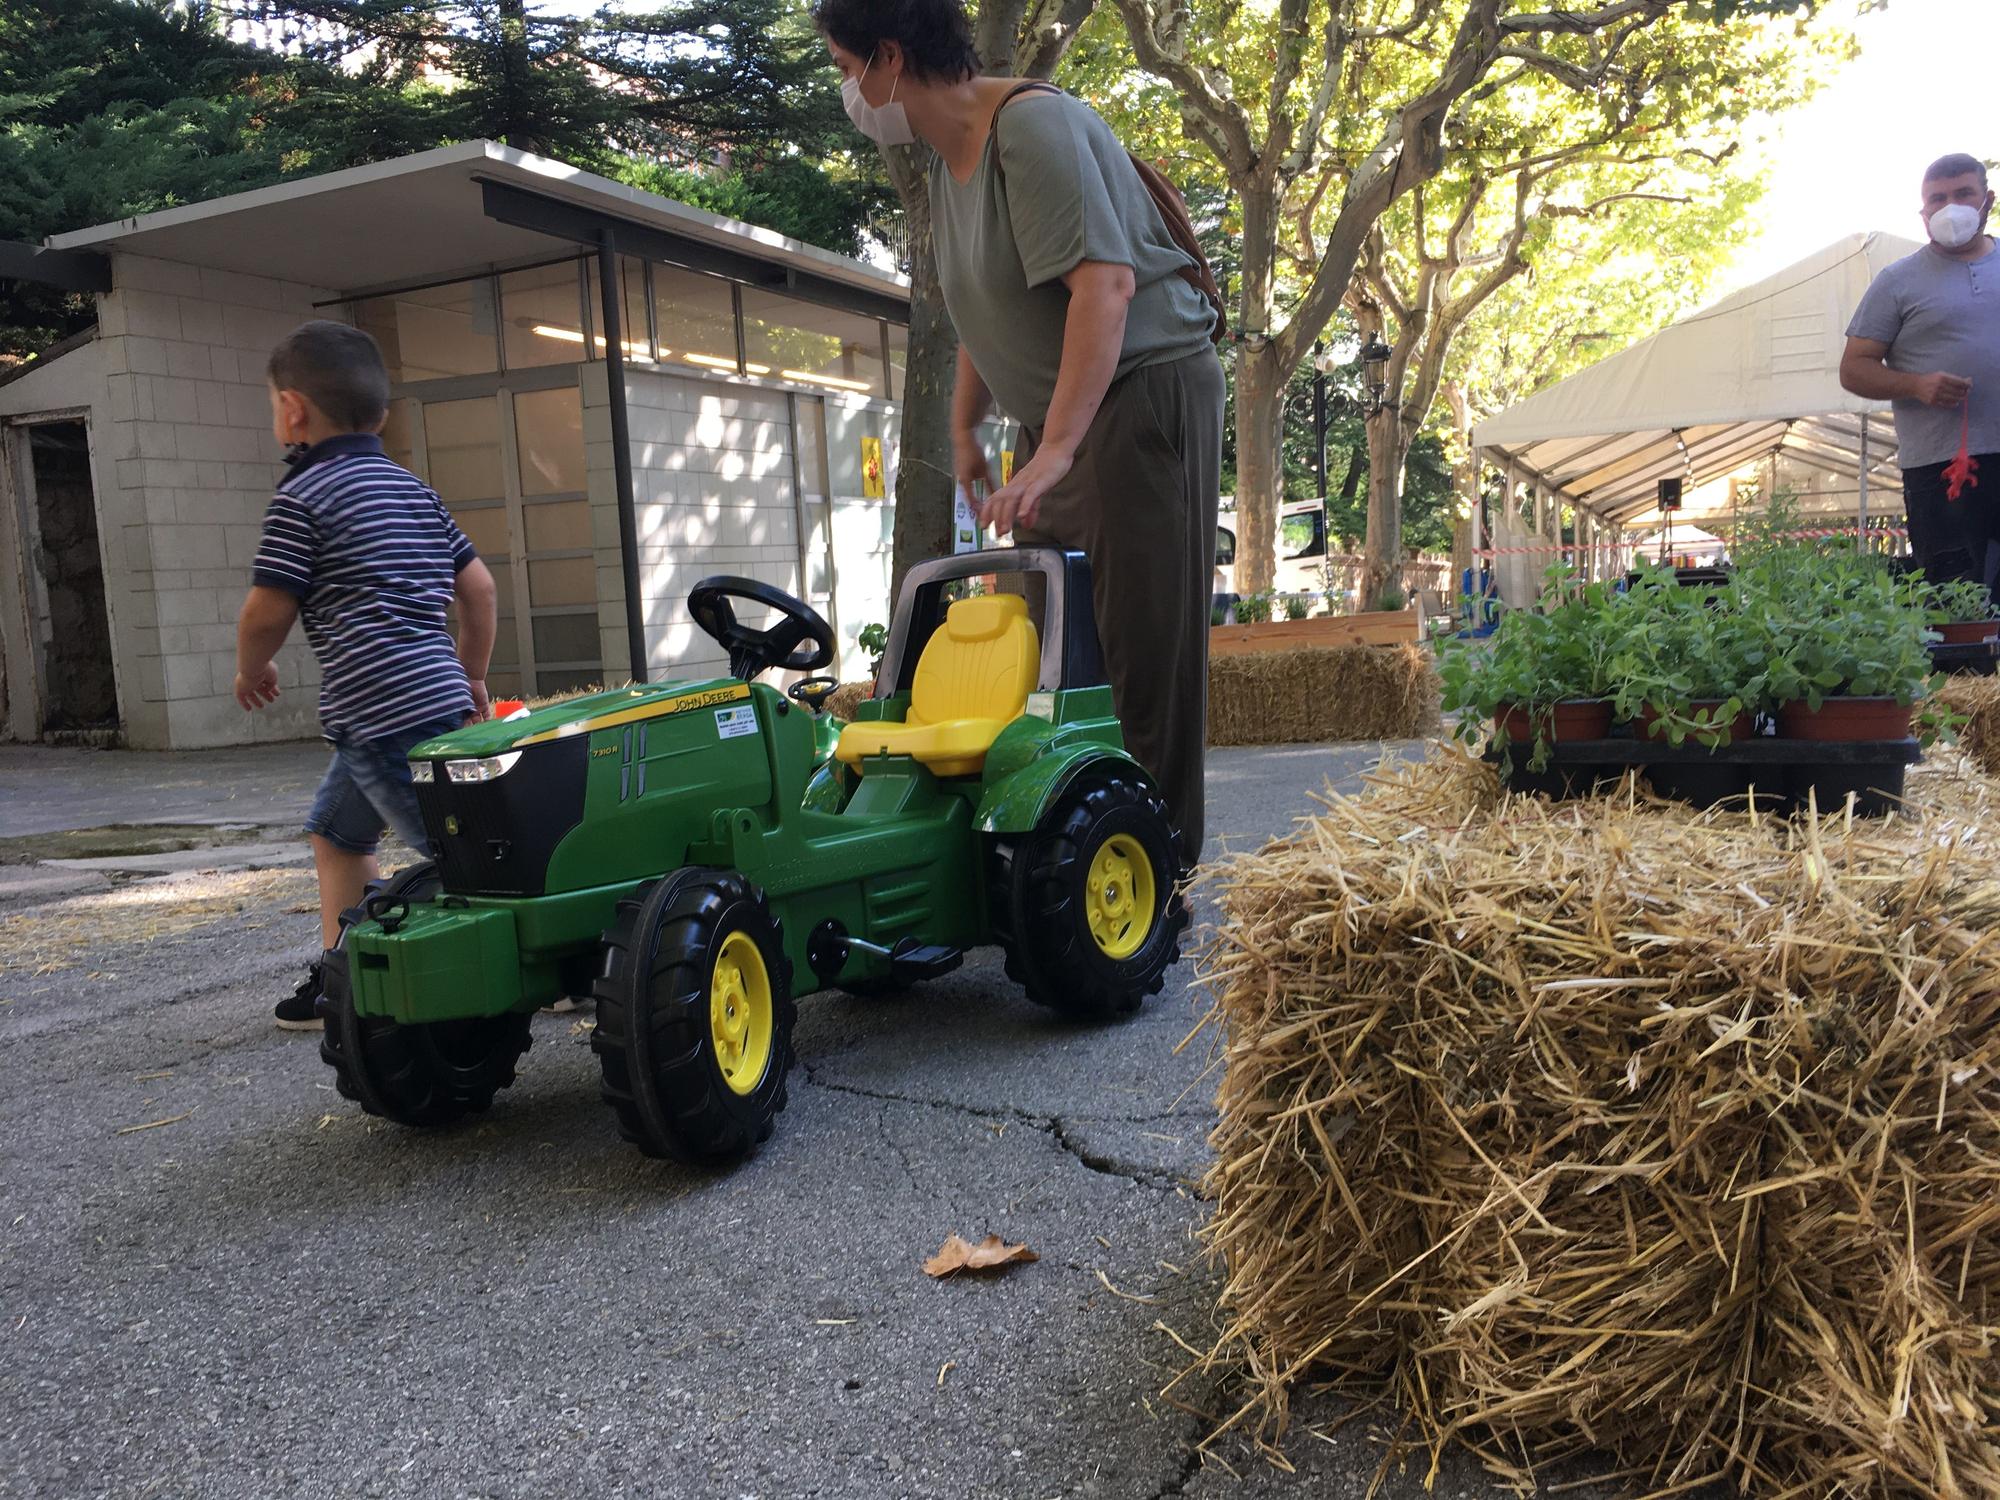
[1472,234,1918,560]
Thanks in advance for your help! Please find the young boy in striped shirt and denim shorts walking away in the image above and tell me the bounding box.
[236,322,494,1030]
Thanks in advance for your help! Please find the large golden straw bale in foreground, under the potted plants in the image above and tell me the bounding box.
[1204,750,2000,1496]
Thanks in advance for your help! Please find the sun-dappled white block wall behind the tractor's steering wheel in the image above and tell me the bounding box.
[582,364,800,682]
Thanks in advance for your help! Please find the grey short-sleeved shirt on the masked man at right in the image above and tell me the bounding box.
[1848,244,2000,468]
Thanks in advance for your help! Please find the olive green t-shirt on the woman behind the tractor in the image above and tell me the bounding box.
[930,94,1214,428]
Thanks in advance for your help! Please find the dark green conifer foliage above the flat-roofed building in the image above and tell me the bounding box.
[0,0,882,354]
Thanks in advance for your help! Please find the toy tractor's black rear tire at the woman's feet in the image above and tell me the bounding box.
[988,766,1188,1020]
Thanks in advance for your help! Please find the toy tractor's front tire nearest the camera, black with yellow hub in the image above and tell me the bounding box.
[590,868,798,1166]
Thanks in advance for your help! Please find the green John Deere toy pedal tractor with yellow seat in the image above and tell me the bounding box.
[320,548,1188,1164]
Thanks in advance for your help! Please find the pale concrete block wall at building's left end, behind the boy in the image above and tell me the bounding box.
[92,256,330,750]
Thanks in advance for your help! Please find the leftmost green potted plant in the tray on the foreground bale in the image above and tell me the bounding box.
[1438,570,1624,770]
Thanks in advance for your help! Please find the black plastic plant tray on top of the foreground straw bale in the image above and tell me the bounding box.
[1486,734,1924,818]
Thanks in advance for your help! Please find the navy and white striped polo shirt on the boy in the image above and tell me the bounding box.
[250,432,478,740]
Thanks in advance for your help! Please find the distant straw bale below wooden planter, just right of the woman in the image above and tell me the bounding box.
[1208,646,1440,744]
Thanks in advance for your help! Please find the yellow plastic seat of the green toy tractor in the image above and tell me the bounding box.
[834,594,1042,776]
